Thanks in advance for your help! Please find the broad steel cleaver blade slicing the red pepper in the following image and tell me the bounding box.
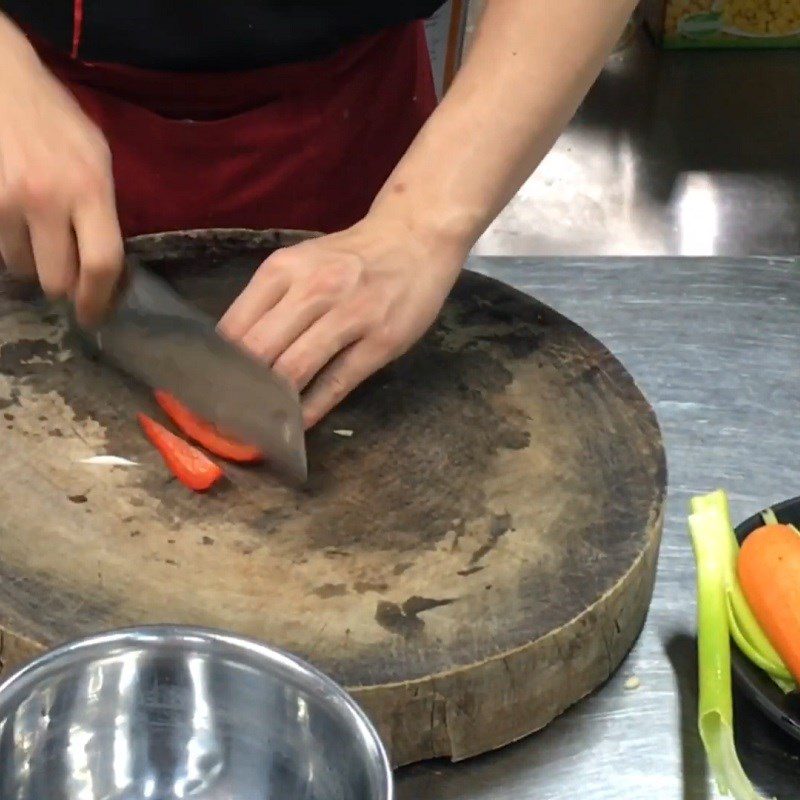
[74,256,308,483]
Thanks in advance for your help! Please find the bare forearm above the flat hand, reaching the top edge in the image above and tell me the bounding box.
[372,0,636,254]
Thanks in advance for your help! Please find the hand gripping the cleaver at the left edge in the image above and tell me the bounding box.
[0,23,123,326]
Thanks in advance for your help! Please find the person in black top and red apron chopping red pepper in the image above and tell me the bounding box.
[0,0,635,426]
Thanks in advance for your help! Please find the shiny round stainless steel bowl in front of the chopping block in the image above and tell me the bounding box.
[0,626,393,800]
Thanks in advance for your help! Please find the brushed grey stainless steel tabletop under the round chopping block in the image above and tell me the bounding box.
[398,258,800,800]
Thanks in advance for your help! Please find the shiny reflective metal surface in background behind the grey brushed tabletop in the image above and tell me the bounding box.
[475,31,800,256]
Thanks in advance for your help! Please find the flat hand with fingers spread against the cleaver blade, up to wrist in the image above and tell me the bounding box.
[220,217,465,427]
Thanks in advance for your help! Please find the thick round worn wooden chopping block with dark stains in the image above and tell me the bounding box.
[0,231,665,764]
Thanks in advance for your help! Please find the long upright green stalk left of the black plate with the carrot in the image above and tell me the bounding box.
[689,510,764,800]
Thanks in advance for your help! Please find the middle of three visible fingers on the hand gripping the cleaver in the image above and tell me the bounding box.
[30,212,78,299]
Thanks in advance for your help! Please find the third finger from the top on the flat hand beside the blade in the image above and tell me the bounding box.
[273,309,365,392]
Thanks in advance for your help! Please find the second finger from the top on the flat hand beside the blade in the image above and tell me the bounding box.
[242,289,333,364]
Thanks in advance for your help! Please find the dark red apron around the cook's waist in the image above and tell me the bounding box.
[29,23,436,236]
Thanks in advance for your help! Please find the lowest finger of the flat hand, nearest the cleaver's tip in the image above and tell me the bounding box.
[303,339,389,428]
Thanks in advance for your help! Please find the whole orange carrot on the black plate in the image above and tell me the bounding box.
[737,525,800,682]
